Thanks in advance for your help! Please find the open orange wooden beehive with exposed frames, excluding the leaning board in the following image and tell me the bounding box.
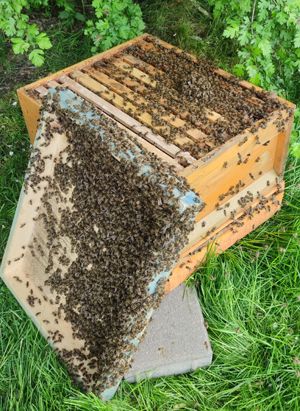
[18,34,294,291]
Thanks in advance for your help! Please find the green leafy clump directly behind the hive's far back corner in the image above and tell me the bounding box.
[85,0,145,52]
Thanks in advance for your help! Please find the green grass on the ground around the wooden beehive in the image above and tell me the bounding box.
[0,1,300,411]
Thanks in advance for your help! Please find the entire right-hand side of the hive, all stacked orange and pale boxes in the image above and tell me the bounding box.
[166,108,293,292]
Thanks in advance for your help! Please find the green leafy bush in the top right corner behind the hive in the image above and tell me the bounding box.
[209,0,300,96]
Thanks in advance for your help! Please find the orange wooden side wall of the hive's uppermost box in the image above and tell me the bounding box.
[182,111,293,222]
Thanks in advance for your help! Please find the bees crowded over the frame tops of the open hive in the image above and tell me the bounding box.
[95,36,292,158]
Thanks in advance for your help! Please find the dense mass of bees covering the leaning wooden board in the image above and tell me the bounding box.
[19,92,201,392]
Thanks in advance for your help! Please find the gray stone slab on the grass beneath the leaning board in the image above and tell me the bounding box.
[124,285,212,382]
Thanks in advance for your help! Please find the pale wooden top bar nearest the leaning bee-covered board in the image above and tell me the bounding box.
[59,76,180,158]
